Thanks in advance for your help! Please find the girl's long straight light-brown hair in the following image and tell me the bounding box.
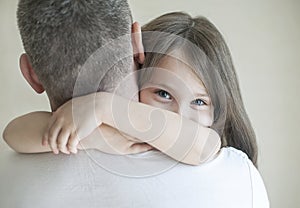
[139,12,257,165]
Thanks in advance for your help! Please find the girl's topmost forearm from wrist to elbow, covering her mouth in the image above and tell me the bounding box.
[95,92,221,165]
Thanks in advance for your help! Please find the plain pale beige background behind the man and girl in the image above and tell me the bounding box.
[0,0,300,208]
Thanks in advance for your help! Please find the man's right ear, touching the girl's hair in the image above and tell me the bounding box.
[131,22,145,64]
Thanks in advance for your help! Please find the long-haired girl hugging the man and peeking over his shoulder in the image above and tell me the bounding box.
[5,13,257,165]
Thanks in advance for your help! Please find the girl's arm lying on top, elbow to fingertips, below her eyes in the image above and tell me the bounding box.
[45,92,221,165]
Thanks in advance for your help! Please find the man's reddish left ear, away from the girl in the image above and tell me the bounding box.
[20,53,45,94]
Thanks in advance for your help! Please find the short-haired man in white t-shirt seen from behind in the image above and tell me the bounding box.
[0,0,268,207]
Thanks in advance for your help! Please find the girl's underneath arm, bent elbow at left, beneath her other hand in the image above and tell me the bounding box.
[3,112,152,154]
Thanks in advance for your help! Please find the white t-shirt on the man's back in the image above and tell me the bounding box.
[0,148,269,208]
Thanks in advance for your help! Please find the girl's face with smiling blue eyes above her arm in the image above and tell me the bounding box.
[140,56,214,127]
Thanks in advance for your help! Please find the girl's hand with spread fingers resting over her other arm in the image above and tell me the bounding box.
[42,94,101,154]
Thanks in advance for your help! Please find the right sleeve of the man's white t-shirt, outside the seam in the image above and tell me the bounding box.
[249,162,270,208]
